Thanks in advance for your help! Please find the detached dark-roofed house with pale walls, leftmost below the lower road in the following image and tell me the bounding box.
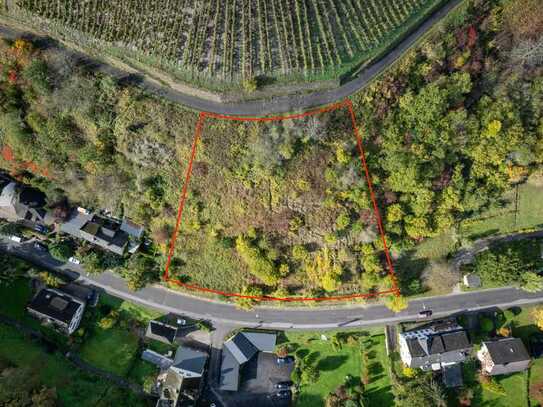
[27,288,86,335]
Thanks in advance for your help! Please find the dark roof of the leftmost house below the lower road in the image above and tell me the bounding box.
[28,288,83,324]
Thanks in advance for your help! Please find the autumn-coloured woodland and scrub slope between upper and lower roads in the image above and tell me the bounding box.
[0,0,543,302]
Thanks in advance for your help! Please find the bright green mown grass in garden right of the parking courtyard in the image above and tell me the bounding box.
[285,329,393,407]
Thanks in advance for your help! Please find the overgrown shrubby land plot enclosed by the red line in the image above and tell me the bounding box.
[164,101,398,301]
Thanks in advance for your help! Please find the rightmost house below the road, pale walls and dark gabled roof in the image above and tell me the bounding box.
[477,338,530,376]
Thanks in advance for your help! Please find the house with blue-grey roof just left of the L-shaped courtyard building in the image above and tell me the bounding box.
[152,346,208,407]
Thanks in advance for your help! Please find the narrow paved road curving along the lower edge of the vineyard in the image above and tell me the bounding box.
[0,0,463,116]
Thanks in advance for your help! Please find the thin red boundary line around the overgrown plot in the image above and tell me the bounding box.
[163,99,400,302]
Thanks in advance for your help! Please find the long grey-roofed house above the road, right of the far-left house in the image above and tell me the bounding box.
[60,208,143,255]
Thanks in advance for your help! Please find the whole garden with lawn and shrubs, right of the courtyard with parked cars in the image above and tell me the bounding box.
[278,328,393,407]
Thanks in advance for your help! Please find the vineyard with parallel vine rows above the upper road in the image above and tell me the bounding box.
[6,0,441,89]
